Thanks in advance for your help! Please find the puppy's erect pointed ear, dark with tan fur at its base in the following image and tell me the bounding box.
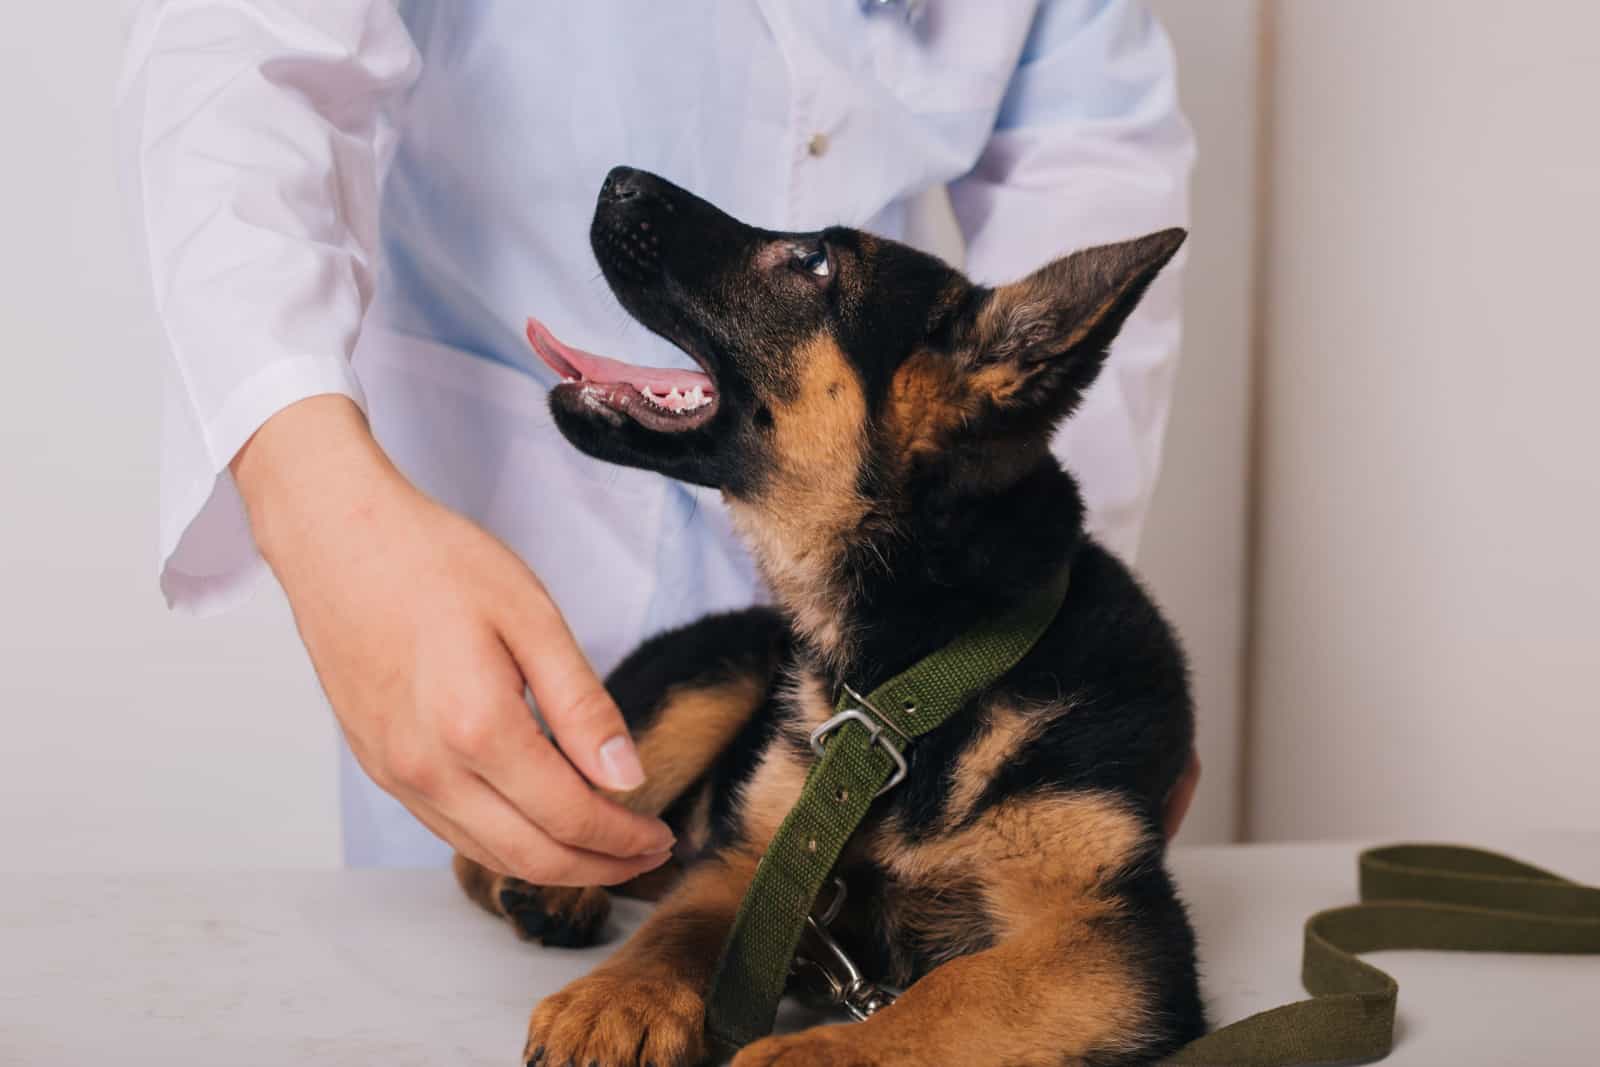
[963,229,1187,421]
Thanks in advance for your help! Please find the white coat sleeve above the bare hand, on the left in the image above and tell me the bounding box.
[117,0,419,611]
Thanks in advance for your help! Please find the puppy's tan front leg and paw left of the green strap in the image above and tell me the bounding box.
[523,851,757,1067]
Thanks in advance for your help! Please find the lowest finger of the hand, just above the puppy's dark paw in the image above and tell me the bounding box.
[440,777,672,886]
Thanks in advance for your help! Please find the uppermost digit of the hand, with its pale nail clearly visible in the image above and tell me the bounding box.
[502,579,645,792]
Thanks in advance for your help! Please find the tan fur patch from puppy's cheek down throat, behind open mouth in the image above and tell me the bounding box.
[730,333,869,656]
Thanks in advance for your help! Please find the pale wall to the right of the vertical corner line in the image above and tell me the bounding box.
[1250,0,1600,838]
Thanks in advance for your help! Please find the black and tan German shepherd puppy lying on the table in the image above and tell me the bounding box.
[456,168,1205,1067]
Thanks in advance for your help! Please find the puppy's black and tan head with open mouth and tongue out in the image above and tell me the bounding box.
[544,168,1184,639]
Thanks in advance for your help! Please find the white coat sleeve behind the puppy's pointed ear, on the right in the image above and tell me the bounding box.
[950,0,1194,560]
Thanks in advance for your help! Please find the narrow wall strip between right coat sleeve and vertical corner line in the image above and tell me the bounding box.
[1139,0,1261,843]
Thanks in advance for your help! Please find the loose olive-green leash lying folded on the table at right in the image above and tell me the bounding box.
[1165,845,1600,1067]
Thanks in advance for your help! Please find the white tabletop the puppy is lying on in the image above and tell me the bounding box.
[0,833,1600,1067]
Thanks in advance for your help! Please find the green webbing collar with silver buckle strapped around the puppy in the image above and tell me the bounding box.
[706,569,1067,1057]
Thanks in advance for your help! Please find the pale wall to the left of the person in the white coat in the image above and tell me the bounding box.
[0,0,339,870]
